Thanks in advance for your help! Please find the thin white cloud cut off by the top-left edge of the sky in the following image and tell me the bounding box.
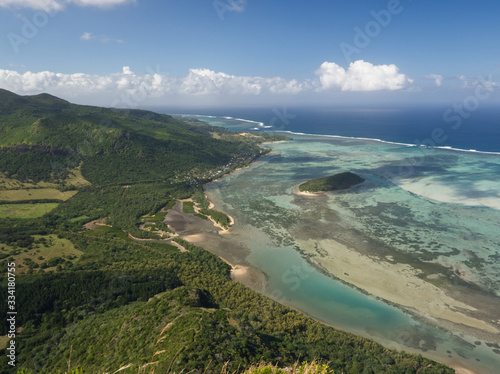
[0,0,135,12]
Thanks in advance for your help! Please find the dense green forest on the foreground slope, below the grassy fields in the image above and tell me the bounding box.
[0,234,452,373]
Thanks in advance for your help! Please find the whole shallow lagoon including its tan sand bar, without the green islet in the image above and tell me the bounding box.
[181,136,500,373]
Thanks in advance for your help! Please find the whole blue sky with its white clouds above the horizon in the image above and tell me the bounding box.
[0,0,500,107]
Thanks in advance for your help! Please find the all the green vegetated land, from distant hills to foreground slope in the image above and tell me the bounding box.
[0,90,453,374]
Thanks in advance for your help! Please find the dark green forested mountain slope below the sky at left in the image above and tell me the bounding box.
[0,90,266,185]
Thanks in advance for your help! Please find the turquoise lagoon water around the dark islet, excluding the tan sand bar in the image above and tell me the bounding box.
[188,117,500,373]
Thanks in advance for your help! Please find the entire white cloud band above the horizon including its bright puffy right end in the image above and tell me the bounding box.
[0,60,411,107]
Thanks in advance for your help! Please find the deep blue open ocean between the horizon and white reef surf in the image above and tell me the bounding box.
[158,105,500,152]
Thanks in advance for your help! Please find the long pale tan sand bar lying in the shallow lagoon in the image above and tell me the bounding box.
[298,239,500,334]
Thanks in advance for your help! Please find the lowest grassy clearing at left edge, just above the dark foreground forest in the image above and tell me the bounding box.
[0,235,82,272]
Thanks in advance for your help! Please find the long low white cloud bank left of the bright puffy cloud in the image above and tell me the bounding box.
[0,66,309,101]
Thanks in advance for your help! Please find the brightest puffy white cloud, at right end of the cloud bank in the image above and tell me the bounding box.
[316,60,413,91]
